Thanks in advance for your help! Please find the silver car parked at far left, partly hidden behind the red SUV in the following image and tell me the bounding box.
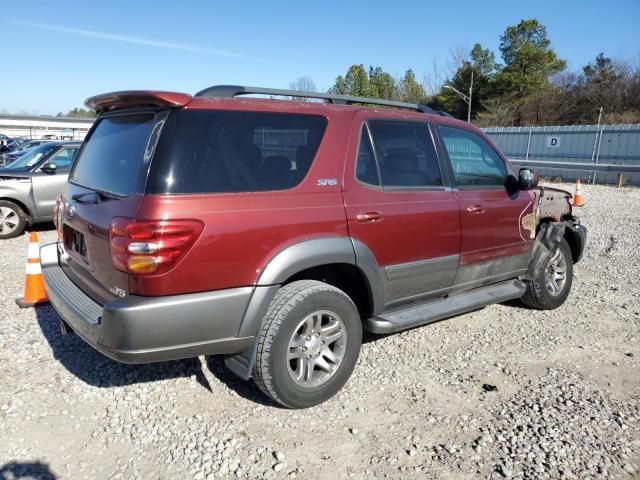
[0,142,80,240]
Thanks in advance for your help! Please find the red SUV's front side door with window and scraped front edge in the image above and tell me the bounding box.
[438,126,534,291]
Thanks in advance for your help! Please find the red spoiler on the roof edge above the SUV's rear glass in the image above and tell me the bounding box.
[84,90,192,114]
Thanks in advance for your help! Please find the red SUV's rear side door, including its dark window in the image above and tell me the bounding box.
[343,114,460,308]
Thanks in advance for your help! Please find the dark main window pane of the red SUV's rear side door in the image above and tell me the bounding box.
[369,121,442,187]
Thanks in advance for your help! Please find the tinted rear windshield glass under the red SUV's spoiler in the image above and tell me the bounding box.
[69,113,154,196]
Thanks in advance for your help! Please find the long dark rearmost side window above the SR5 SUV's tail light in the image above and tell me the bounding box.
[147,110,327,194]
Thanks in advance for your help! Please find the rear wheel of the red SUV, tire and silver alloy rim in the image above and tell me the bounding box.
[253,280,362,408]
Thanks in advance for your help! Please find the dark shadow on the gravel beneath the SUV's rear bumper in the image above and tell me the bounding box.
[34,306,211,390]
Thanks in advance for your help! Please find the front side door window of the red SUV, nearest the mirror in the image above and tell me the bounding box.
[440,127,507,186]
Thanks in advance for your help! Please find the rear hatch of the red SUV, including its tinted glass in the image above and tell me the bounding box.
[58,110,168,304]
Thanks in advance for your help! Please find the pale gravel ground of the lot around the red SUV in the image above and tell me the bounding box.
[0,182,640,480]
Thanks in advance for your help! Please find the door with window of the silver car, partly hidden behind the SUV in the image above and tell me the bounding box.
[32,145,79,219]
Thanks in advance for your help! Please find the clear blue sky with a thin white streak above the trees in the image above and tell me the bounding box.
[0,0,640,115]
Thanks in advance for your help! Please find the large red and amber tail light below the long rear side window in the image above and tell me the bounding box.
[109,217,203,275]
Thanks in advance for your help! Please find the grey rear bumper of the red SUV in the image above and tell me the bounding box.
[40,243,254,363]
